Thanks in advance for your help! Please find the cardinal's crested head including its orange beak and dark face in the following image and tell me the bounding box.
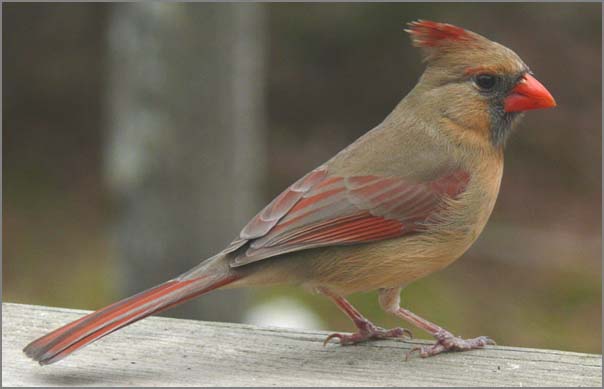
[406,20,556,146]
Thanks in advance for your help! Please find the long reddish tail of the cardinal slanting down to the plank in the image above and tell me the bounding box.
[23,260,240,365]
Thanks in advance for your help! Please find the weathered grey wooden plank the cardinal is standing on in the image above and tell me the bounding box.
[2,303,602,386]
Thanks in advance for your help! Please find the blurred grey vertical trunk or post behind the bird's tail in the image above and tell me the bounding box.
[106,3,265,321]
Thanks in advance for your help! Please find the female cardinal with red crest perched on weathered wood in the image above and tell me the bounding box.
[23,19,556,365]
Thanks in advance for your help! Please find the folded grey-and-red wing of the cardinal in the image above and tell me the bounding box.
[224,166,470,267]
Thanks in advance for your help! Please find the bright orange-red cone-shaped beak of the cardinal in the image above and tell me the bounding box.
[504,73,556,112]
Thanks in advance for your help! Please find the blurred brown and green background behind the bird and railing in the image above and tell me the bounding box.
[2,3,602,353]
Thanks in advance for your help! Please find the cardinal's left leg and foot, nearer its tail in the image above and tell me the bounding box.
[319,288,412,346]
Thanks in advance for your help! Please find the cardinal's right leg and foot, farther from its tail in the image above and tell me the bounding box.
[379,288,495,358]
